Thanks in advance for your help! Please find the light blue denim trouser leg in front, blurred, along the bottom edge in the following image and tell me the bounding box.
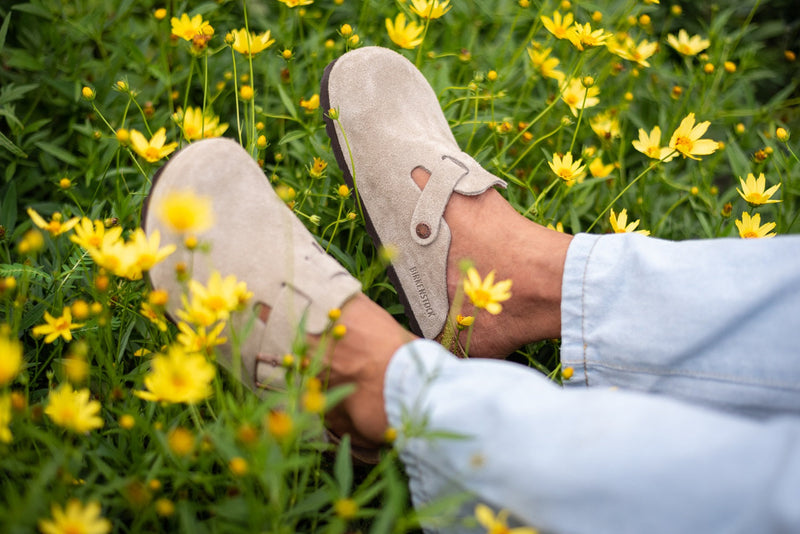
[385,340,800,534]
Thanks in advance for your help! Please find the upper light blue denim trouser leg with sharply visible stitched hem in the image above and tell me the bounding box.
[561,234,800,416]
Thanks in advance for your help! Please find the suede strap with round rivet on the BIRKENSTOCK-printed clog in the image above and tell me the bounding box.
[409,152,506,246]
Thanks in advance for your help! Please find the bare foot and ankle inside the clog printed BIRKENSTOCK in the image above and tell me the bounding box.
[411,167,572,358]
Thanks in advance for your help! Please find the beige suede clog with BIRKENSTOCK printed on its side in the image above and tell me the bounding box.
[320,47,506,338]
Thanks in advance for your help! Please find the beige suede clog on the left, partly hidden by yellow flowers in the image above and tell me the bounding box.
[143,138,361,390]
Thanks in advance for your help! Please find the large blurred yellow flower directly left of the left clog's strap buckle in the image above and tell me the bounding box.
[134,345,216,404]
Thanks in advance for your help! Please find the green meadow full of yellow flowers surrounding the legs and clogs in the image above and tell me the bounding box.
[0,0,800,533]
